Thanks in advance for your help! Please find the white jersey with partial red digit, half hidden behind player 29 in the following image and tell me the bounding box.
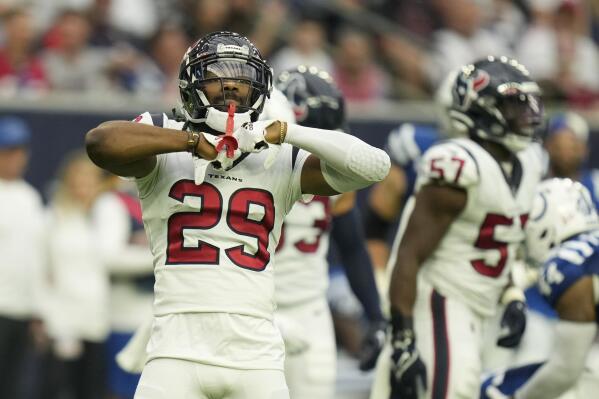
[275,196,336,306]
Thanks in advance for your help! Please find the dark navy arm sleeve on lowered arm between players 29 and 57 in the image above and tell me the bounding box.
[331,207,384,322]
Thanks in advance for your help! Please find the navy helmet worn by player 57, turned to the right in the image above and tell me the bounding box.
[449,56,543,152]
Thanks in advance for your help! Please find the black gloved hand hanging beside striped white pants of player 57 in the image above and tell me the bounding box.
[390,322,426,399]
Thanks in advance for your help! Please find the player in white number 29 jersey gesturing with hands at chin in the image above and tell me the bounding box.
[86,32,390,399]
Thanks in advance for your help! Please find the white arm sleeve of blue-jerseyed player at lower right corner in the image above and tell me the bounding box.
[515,320,597,399]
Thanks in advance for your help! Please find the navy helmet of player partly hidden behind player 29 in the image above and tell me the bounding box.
[275,65,347,131]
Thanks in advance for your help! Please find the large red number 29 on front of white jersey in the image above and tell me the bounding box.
[166,180,275,271]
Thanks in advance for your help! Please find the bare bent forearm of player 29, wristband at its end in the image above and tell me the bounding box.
[85,121,216,167]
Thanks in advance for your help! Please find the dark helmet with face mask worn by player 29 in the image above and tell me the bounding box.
[179,32,273,132]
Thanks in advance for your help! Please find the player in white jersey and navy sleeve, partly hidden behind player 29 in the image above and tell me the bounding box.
[275,65,386,399]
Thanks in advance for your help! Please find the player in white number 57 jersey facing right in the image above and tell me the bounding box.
[372,57,543,399]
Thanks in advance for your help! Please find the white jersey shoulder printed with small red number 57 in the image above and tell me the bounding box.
[418,141,479,188]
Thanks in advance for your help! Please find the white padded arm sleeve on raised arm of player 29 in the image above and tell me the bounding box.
[285,124,391,193]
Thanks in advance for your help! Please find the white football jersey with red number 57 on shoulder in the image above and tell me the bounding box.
[391,138,543,316]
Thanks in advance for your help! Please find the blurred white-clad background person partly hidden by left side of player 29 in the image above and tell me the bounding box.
[93,176,154,399]
